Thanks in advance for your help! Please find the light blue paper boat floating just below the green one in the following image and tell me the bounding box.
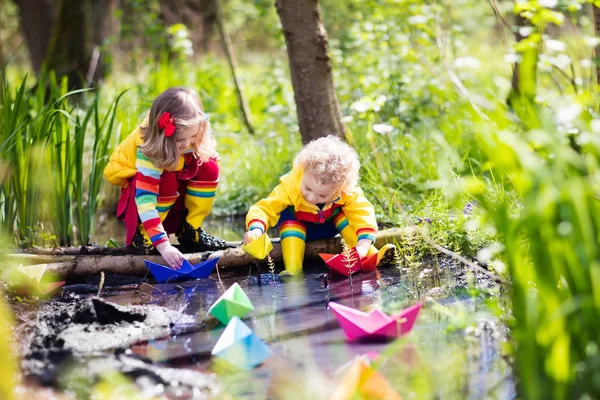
[210,317,271,370]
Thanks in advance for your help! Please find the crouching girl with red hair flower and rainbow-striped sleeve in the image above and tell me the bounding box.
[104,87,227,269]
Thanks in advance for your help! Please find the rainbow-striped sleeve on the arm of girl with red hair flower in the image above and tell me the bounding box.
[135,147,169,247]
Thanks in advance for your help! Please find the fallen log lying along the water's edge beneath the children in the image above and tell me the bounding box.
[6,228,412,277]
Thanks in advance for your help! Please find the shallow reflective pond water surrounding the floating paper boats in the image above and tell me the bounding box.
[99,263,515,399]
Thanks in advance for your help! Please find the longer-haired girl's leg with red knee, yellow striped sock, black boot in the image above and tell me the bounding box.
[178,160,226,251]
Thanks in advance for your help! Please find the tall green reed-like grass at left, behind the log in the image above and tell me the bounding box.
[0,73,122,246]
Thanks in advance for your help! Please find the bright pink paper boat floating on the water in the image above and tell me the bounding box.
[329,302,422,342]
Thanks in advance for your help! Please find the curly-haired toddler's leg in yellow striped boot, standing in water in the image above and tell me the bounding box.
[277,208,306,275]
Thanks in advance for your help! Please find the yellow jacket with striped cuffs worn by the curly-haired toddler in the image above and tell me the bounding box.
[246,168,377,242]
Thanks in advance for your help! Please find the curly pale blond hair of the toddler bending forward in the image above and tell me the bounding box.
[294,135,360,193]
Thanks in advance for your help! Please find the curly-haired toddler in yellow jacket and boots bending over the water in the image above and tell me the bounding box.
[244,136,395,275]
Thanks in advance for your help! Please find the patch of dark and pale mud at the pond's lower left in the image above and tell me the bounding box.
[22,297,215,397]
